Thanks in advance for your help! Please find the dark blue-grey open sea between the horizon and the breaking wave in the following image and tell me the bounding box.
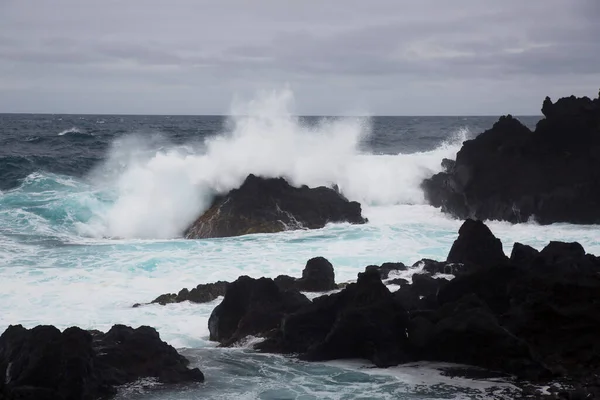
[0,114,539,190]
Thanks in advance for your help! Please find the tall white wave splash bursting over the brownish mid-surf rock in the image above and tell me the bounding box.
[80,90,466,238]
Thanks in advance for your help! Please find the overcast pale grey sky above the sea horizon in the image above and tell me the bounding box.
[0,0,600,115]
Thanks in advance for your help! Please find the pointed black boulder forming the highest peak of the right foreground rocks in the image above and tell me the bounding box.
[447,219,509,267]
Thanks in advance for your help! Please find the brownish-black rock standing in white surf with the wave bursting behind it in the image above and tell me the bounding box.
[185,175,367,239]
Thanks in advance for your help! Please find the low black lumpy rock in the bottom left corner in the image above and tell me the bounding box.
[0,325,204,400]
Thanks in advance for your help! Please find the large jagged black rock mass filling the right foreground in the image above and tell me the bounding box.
[209,220,600,393]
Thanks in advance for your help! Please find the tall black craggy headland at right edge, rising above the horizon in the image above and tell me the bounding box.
[422,90,600,224]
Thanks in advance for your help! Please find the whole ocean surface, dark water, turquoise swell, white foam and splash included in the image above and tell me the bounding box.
[0,92,600,400]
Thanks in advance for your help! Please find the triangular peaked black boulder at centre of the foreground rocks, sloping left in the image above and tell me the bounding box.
[258,271,408,366]
